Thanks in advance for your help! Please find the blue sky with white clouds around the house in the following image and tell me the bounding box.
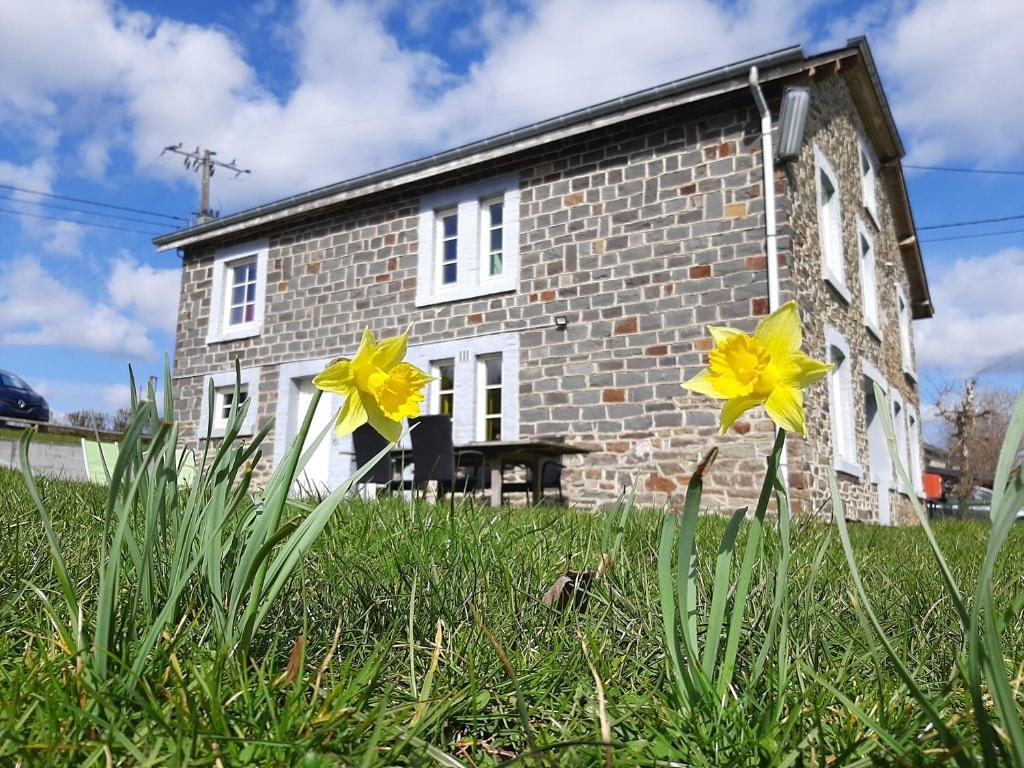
[0,0,1024,434]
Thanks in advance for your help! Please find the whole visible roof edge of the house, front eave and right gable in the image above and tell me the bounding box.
[153,37,933,318]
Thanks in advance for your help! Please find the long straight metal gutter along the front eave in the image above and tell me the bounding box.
[153,45,804,251]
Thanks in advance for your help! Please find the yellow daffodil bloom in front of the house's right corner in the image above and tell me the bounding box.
[683,301,831,437]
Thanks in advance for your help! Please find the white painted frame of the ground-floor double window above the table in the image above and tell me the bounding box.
[406,333,519,443]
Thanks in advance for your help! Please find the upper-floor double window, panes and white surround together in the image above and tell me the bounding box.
[416,174,519,306]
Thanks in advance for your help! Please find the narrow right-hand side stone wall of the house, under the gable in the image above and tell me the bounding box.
[780,74,921,522]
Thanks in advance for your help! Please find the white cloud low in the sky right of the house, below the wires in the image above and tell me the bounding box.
[914,248,1024,376]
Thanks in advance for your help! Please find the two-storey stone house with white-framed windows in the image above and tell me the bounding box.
[155,39,933,522]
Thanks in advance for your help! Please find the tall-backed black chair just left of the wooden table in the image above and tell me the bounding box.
[409,414,487,497]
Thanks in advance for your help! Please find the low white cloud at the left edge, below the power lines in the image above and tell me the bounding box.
[0,257,154,357]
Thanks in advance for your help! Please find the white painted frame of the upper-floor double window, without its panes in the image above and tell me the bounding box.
[416,173,519,307]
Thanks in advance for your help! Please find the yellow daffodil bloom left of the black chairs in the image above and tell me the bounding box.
[313,331,432,442]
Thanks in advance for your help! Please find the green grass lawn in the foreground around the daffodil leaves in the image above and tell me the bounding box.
[0,471,1024,766]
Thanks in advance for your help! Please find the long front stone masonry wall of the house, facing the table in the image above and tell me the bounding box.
[175,93,771,507]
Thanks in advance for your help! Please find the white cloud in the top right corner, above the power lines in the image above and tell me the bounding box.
[873,0,1024,165]
